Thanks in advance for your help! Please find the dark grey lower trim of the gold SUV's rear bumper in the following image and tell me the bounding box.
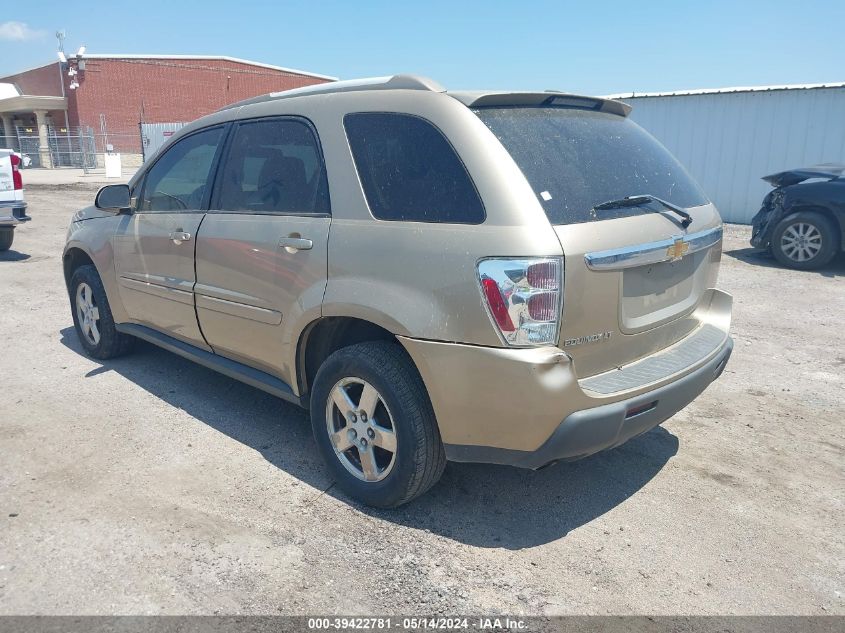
[446,337,733,469]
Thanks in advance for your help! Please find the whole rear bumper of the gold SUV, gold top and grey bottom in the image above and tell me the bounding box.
[398,289,733,468]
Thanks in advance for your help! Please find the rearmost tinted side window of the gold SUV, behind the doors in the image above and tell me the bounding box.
[344,112,484,224]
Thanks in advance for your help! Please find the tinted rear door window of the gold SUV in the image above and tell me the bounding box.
[216,119,329,214]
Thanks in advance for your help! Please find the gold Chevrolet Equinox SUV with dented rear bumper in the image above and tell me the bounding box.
[64,75,733,507]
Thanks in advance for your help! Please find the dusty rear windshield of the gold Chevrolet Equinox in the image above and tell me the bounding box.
[475,107,707,224]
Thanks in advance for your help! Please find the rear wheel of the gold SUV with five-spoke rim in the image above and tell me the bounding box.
[311,341,446,508]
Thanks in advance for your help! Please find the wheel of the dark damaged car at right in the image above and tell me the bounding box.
[771,211,839,270]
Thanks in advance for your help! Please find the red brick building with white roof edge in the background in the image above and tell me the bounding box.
[0,54,335,167]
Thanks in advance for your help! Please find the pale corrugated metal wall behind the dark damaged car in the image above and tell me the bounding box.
[624,88,845,223]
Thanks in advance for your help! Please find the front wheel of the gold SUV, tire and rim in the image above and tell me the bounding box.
[69,265,135,360]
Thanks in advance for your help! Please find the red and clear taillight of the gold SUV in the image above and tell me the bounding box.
[478,258,562,346]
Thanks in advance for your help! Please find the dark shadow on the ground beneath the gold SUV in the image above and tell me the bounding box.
[60,327,678,550]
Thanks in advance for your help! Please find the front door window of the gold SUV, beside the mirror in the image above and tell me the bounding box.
[139,127,223,211]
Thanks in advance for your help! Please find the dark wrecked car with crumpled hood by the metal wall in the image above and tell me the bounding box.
[751,163,845,270]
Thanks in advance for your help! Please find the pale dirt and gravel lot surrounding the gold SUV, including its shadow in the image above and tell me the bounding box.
[0,185,845,615]
